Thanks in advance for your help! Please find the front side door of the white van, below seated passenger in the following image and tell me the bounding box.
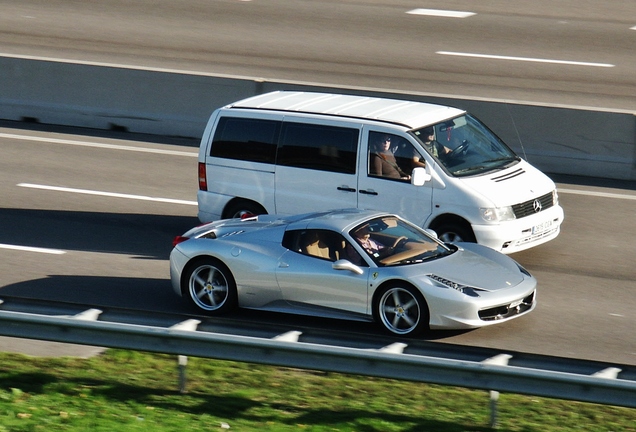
[358,127,433,226]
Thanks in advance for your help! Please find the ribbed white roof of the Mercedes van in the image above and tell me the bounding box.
[228,91,465,129]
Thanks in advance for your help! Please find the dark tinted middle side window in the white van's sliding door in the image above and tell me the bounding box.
[277,122,359,174]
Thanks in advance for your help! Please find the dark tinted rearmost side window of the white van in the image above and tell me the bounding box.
[210,117,280,164]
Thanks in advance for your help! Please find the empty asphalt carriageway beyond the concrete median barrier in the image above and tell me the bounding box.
[0,0,636,111]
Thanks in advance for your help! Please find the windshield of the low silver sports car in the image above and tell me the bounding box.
[349,216,453,266]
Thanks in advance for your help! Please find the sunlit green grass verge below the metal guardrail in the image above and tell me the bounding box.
[0,350,636,432]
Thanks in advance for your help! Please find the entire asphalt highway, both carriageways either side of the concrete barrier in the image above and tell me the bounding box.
[0,0,636,365]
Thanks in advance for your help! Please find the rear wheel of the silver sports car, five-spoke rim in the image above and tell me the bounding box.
[182,258,238,315]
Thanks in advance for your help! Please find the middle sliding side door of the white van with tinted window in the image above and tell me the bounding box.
[275,117,360,214]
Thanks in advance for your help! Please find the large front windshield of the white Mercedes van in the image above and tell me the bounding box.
[411,114,521,177]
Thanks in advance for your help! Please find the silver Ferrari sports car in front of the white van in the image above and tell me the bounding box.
[170,209,536,335]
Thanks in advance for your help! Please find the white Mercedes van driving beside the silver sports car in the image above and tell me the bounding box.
[197,91,563,253]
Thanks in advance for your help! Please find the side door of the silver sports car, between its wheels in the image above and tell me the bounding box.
[276,230,370,315]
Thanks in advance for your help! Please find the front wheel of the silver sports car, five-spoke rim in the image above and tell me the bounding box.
[374,284,429,336]
